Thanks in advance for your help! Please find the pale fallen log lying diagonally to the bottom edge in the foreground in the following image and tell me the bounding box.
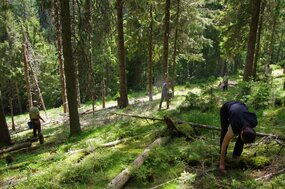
[107,137,170,189]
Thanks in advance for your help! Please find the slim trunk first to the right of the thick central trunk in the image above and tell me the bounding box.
[147,4,153,101]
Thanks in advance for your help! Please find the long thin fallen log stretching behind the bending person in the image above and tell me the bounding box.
[114,113,285,141]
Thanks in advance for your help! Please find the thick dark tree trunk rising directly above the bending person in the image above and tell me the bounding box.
[243,0,261,81]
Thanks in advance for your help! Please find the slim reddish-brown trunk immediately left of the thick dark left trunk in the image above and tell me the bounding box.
[54,0,68,113]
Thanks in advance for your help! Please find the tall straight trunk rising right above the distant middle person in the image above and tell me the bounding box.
[172,0,180,97]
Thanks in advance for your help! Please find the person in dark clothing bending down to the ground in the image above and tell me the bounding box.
[219,101,257,173]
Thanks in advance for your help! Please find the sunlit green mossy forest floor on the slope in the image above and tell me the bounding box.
[0,70,285,189]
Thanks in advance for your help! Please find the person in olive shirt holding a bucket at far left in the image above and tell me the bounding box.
[29,100,44,144]
